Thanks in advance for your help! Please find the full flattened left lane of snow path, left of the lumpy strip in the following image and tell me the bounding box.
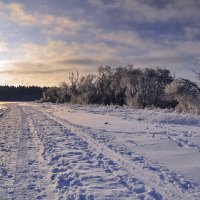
[0,106,51,200]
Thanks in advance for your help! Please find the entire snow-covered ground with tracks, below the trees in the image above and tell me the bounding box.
[0,103,200,200]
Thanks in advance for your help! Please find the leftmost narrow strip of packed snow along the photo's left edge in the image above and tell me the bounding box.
[0,105,20,200]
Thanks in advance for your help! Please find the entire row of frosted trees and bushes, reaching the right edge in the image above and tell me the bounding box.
[41,66,200,113]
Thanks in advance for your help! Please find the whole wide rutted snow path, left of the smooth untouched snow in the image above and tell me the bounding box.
[0,104,200,200]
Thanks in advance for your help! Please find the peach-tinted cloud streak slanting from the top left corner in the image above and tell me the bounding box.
[0,2,86,35]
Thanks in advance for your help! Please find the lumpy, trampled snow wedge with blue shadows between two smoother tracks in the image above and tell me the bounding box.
[29,108,141,200]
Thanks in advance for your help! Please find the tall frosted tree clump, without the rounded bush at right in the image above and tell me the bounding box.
[39,66,173,108]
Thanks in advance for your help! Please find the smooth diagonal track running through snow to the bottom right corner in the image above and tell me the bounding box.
[32,105,199,199]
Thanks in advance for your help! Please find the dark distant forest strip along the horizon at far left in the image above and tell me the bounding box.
[0,86,47,101]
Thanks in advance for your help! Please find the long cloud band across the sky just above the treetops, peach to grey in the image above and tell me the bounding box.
[0,35,200,75]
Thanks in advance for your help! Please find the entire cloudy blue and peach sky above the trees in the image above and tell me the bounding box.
[0,0,200,86]
